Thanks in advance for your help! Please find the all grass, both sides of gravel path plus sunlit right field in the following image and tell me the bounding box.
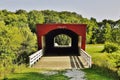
[0,44,119,80]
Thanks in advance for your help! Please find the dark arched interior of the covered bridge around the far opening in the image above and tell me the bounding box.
[44,29,79,56]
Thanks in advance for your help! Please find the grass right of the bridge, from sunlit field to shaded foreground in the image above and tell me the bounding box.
[83,44,119,80]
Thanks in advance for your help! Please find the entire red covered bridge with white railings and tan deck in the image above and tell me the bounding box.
[29,24,92,69]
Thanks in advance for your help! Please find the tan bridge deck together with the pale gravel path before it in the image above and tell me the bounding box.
[33,56,86,80]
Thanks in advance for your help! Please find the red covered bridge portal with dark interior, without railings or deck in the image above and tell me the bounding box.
[37,24,86,56]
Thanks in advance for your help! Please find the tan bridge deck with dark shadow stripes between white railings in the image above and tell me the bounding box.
[33,56,84,70]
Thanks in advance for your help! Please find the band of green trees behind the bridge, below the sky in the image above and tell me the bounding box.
[0,9,120,44]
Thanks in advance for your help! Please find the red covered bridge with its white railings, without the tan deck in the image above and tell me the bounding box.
[29,24,91,68]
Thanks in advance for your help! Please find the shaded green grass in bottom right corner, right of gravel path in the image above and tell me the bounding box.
[84,64,120,80]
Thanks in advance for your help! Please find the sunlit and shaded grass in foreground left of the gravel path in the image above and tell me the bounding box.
[0,66,69,80]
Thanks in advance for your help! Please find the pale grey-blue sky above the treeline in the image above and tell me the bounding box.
[0,0,120,21]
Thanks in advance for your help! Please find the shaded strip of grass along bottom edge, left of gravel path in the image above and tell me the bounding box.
[6,72,68,80]
